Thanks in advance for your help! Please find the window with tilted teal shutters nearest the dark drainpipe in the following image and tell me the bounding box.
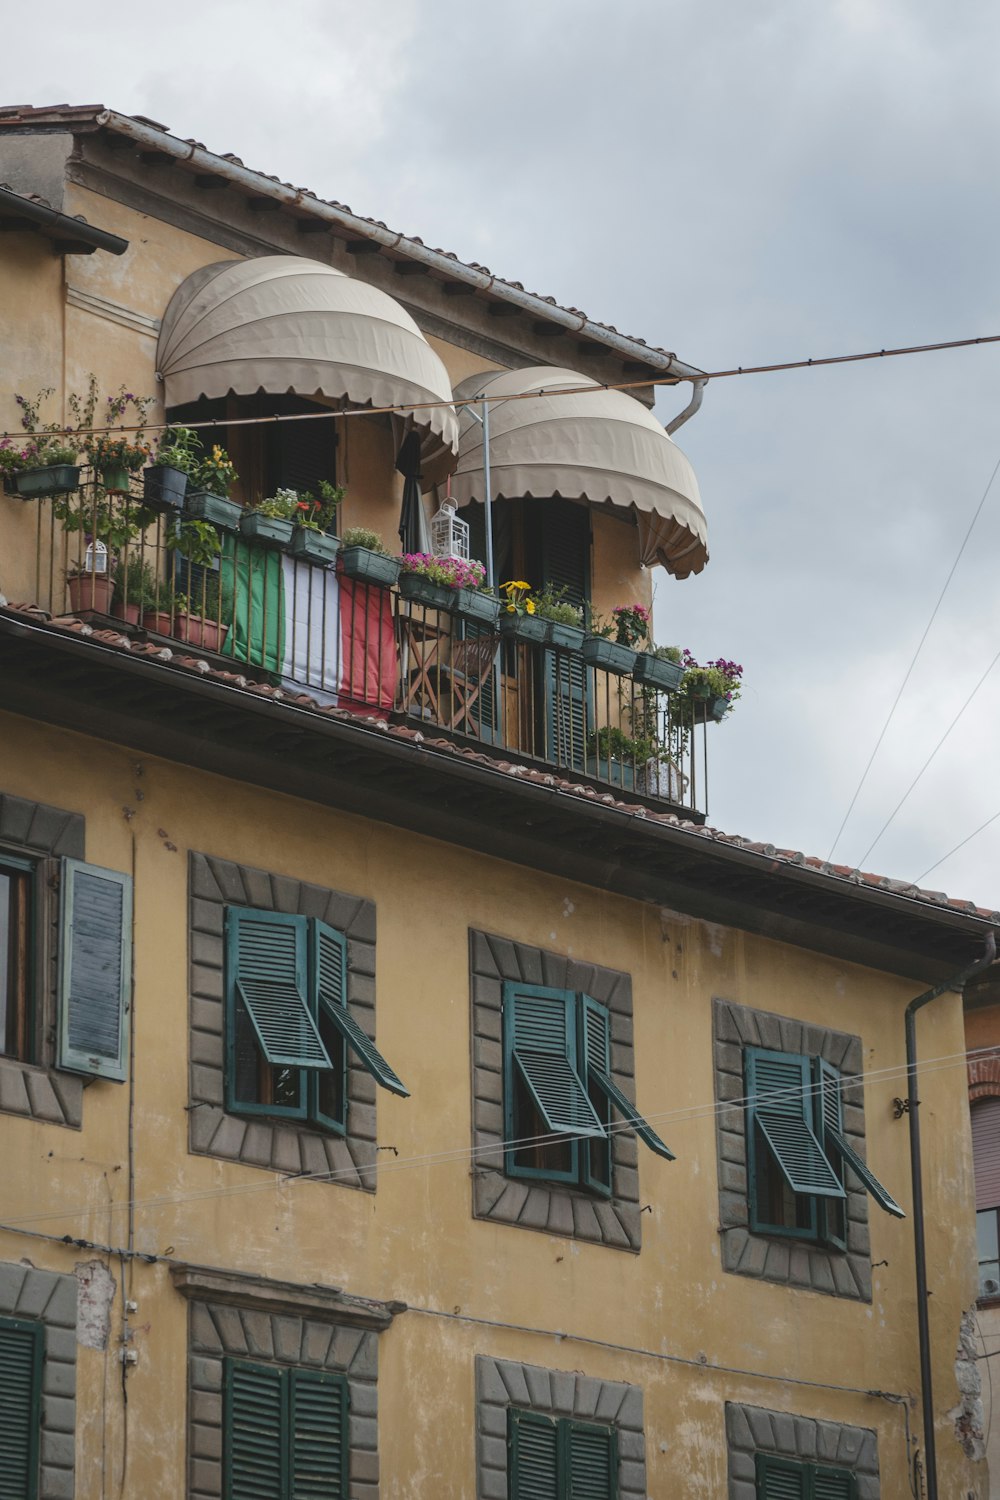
[744,1047,904,1250]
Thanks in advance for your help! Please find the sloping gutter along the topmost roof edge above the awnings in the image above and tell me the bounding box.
[96,110,705,399]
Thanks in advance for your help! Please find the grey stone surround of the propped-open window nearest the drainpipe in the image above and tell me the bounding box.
[712,998,871,1302]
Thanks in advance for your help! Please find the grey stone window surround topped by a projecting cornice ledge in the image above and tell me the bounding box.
[171,1266,395,1500]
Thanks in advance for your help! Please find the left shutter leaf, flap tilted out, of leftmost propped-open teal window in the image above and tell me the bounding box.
[226,906,331,1068]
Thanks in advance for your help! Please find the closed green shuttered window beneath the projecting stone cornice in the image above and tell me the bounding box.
[222,1359,348,1500]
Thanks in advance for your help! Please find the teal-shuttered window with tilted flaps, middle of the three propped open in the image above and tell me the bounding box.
[504,983,673,1196]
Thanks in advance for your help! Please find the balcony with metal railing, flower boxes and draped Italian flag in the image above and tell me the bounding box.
[0,471,721,822]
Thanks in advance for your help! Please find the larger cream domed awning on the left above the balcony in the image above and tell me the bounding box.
[156,255,459,479]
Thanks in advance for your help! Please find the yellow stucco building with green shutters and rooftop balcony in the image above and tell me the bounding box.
[0,110,1000,1500]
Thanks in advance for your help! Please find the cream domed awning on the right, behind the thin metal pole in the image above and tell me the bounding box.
[451,365,708,578]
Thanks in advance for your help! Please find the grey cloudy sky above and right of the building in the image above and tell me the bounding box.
[4,0,1000,908]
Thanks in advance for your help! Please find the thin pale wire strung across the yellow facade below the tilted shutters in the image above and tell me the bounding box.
[3,1046,1000,1229]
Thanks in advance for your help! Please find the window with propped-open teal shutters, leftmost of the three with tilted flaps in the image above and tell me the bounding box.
[225,906,408,1134]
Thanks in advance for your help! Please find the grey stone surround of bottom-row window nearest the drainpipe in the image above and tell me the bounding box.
[726,1401,882,1500]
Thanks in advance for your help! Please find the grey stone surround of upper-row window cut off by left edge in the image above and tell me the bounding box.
[0,792,85,1130]
